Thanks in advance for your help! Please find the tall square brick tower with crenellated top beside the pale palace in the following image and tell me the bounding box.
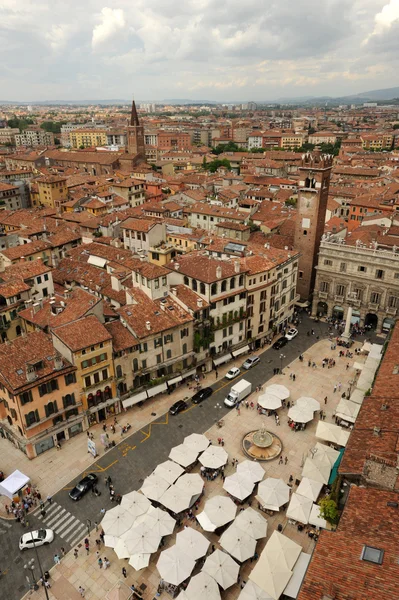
[295,152,333,301]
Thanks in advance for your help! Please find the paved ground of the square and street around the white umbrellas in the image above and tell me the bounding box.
[0,321,376,600]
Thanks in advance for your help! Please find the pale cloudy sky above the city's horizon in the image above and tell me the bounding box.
[0,0,399,101]
